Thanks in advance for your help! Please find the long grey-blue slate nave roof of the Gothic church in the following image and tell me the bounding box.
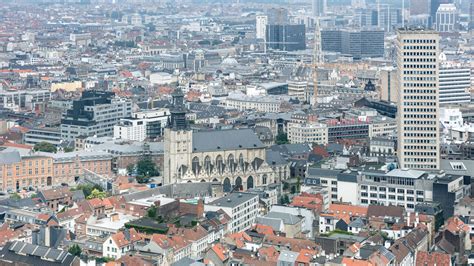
[193,129,265,152]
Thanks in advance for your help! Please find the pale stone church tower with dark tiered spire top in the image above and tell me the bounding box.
[163,88,193,185]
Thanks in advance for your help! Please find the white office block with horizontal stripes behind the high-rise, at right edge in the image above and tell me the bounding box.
[439,65,471,105]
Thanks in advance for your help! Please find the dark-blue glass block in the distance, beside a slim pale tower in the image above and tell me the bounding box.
[266,24,306,51]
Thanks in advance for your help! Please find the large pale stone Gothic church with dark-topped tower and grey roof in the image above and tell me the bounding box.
[163,90,278,192]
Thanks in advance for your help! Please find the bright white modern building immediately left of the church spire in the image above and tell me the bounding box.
[114,108,170,141]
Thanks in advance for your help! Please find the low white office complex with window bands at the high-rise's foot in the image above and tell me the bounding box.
[308,168,448,212]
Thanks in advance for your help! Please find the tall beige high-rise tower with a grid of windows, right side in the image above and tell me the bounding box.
[397,29,440,170]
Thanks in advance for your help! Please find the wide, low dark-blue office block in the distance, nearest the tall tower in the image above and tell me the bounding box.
[321,29,384,59]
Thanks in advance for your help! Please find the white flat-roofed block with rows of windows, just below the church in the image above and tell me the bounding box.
[204,193,259,233]
